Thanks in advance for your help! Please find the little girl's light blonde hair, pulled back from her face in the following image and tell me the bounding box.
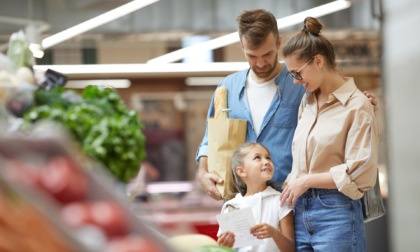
[228,142,276,196]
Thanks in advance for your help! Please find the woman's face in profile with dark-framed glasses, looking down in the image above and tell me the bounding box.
[285,55,319,92]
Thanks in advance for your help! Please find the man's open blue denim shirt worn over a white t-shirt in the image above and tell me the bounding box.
[196,66,305,187]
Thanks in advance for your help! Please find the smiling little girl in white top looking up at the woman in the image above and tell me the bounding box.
[217,143,294,252]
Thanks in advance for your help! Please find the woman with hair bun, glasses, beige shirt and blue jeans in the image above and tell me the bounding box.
[280,17,378,251]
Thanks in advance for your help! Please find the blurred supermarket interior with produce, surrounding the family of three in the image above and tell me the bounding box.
[0,0,420,252]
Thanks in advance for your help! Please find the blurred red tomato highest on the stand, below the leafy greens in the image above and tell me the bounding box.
[40,156,88,203]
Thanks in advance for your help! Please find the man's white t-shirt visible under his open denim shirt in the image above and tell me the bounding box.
[246,73,277,135]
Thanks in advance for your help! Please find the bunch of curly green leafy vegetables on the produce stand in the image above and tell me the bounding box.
[23,86,146,182]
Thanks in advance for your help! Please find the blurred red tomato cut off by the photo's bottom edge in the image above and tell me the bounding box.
[106,236,164,252]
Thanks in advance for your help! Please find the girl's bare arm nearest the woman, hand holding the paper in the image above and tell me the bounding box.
[250,211,295,252]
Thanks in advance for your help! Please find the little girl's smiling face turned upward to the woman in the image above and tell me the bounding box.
[243,145,274,183]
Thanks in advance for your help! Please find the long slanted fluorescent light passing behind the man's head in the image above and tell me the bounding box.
[147,0,351,64]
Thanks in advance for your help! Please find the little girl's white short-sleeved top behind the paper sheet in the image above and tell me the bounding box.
[218,186,292,252]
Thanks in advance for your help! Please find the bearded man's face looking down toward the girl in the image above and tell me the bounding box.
[241,33,280,81]
